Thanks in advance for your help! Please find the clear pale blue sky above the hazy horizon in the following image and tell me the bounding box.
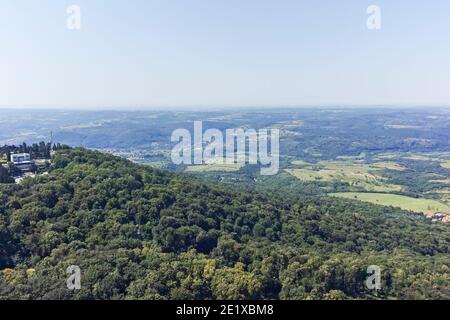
[0,0,450,108]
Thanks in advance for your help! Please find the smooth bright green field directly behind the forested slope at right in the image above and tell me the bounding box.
[330,192,450,214]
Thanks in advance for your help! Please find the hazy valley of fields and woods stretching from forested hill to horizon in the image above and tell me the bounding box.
[0,108,450,220]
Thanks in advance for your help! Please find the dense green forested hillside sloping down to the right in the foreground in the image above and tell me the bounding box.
[0,149,450,299]
